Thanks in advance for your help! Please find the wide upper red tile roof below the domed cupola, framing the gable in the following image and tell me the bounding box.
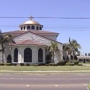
[3,30,62,44]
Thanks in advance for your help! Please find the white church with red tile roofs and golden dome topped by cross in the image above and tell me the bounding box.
[2,17,63,64]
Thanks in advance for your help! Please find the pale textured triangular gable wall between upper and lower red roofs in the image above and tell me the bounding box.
[14,32,52,45]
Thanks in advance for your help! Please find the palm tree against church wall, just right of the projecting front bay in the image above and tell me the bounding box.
[48,42,59,62]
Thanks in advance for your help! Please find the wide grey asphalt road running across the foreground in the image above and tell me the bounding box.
[0,73,90,90]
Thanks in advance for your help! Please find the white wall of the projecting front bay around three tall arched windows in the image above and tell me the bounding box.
[12,45,45,64]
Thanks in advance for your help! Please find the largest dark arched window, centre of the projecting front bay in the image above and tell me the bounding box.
[24,48,32,62]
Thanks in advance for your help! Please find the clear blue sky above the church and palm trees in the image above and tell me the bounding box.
[0,0,90,54]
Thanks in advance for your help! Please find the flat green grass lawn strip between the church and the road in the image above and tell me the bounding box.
[0,66,90,71]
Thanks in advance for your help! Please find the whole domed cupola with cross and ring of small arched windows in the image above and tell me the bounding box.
[19,16,43,31]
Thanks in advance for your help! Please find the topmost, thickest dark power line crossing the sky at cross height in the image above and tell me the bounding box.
[0,17,90,19]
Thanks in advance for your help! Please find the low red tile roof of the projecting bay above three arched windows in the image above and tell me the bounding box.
[10,40,47,46]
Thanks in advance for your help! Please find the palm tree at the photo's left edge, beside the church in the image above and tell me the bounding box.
[0,31,15,63]
